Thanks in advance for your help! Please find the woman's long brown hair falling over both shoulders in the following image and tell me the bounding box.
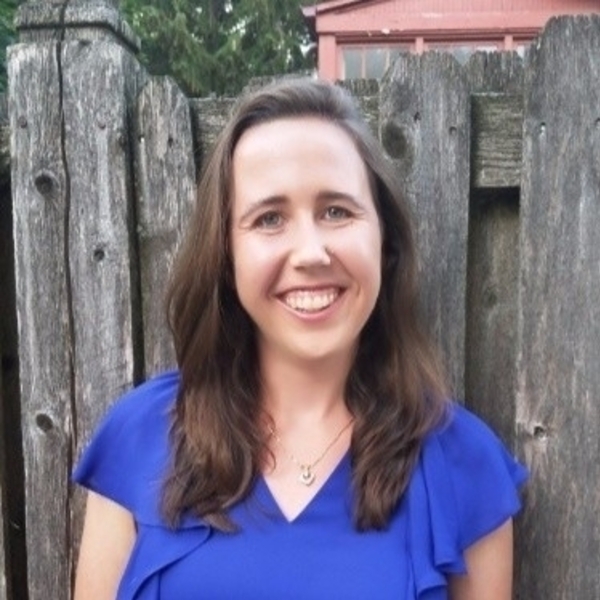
[163,79,445,530]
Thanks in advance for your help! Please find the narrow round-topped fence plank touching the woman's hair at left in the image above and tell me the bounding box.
[135,78,196,375]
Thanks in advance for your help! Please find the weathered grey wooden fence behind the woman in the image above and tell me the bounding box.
[0,0,600,600]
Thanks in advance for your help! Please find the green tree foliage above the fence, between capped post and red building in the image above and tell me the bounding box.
[121,0,314,96]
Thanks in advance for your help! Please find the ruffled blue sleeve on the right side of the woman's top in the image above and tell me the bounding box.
[407,405,527,600]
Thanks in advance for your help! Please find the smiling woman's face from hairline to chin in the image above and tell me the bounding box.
[230,117,382,360]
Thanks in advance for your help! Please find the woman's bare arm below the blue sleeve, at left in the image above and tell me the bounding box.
[75,492,136,600]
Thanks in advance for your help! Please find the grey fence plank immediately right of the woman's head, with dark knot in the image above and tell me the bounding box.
[380,53,470,397]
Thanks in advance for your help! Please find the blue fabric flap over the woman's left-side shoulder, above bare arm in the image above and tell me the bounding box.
[73,372,179,521]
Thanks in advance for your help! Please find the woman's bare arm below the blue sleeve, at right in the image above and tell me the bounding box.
[450,519,513,600]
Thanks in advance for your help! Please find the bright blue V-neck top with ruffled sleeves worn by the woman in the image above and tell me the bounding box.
[74,372,527,600]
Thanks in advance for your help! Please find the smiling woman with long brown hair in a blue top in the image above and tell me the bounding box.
[75,80,524,600]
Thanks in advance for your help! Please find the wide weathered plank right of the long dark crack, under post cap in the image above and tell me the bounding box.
[61,41,142,593]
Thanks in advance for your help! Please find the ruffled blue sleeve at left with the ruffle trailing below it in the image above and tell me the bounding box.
[73,372,210,600]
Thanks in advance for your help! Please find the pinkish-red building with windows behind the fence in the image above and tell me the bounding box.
[302,0,600,80]
